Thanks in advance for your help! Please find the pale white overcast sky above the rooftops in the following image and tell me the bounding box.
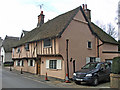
[0,0,119,39]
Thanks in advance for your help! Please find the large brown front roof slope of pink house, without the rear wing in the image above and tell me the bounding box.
[15,7,80,46]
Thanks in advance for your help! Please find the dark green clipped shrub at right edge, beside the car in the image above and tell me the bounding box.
[112,57,120,74]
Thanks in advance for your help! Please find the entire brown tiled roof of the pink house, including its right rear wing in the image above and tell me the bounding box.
[14,6,117,47]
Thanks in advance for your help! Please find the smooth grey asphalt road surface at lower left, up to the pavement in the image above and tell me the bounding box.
[0,68,56,88]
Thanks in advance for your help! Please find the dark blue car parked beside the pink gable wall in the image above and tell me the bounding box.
[73,62,110,86]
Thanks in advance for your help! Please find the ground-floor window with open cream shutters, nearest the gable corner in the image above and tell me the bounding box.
[46,60,62,69]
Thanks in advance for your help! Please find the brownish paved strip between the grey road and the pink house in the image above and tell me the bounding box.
[5,67,110,88]
